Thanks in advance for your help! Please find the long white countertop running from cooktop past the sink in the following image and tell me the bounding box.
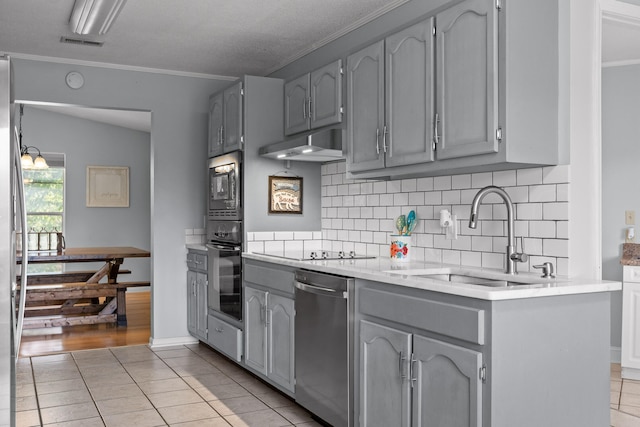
[242,252,622,301]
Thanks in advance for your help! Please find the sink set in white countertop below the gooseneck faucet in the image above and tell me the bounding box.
[385,269,549,288]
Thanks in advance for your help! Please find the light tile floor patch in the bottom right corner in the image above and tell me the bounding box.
[611,363,640,427]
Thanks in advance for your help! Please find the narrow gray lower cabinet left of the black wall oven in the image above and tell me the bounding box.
[187,249,207,341]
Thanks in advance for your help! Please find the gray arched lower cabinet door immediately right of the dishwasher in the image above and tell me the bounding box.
[359,320,410,427]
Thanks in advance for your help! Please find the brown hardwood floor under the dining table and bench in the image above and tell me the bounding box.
[20,291,151,357]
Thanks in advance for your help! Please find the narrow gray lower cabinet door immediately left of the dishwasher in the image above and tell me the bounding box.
[267,294,295,392]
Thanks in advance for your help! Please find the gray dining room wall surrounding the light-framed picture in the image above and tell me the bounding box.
[22,105,151,281]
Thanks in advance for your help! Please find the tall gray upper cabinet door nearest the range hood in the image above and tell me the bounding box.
[347,40,384,172]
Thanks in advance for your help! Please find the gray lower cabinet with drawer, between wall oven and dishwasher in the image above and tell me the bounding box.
[244,260,295,395]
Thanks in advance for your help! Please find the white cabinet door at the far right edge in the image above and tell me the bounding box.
[622,282,640,369]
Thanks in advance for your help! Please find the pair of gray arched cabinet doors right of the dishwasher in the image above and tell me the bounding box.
[360,320,482,427]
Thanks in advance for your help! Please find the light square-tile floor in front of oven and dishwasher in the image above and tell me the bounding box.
[16,344,320,427]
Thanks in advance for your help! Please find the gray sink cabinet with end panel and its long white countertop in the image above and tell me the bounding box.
[243,253,621,427]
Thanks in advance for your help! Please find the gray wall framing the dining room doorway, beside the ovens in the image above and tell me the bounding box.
[13,59,228,345]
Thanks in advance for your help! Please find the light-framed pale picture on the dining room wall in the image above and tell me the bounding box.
[87,166,129,208]
